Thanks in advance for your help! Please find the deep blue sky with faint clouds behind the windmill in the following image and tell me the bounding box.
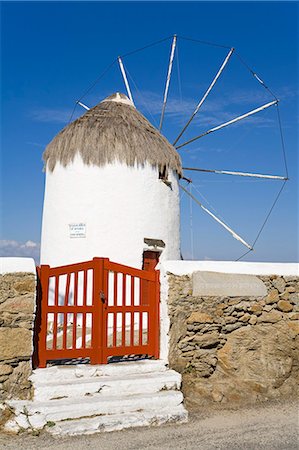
[0,2,298,261]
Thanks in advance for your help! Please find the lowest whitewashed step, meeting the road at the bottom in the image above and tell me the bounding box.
[47,405,188,435]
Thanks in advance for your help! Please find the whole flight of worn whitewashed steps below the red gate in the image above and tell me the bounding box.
[5,360,188,434]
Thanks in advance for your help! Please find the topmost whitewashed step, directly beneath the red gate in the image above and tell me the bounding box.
[30,359,167,384]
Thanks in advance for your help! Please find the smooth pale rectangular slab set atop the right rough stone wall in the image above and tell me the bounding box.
[192,272,267,297]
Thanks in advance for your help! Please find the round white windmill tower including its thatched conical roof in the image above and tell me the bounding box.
[41,93,182,268]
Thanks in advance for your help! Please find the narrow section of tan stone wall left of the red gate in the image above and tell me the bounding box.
[0,272,36,403]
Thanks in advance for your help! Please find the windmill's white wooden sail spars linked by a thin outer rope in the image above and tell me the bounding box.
[71,35,289,260]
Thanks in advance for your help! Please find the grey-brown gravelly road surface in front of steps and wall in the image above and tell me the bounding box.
[0,403,299,450]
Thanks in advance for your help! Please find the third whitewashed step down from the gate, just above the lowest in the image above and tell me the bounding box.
[8,391,183,428]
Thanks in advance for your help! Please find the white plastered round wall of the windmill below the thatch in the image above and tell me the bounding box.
[41,156,180,268]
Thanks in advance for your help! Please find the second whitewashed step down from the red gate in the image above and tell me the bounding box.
[34,370,181,401]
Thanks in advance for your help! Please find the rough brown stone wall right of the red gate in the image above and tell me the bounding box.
[168,274,299,408]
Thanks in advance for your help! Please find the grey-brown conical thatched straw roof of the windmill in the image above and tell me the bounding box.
[43,94,182,175]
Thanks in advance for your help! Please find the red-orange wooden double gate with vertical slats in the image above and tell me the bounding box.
[34,258,160,367]
